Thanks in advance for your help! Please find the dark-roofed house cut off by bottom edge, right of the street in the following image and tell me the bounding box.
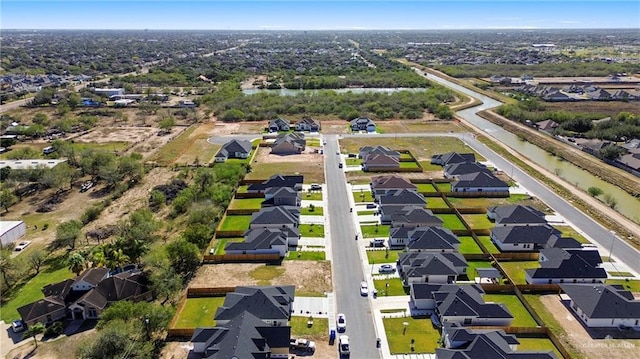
[436,326,557,359]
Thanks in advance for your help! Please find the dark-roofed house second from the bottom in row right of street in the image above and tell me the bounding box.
[410,283,513,326]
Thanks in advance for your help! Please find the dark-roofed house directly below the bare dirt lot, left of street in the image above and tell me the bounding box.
[214,285,295,326]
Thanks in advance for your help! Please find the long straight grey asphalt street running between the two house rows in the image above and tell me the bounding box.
[324,135,380,358]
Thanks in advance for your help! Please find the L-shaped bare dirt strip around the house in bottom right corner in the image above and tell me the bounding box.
[540,294,640,359]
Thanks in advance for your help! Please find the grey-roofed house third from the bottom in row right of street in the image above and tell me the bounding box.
[397,252,468,286]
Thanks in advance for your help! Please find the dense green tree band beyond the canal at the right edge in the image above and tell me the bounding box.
[497,99,640,141]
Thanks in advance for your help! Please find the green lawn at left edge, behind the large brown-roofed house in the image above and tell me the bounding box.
[0,267,74,323]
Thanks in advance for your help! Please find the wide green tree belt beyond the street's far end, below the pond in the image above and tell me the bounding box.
[200,81,454,121]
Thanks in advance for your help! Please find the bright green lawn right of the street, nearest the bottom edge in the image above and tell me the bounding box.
[382,317,440,354]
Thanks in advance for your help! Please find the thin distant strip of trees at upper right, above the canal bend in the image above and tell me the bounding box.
[434,62,640,78]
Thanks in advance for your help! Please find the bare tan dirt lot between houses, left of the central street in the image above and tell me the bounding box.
[189,260,333,294]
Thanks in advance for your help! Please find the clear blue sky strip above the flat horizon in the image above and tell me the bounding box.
[0,0,640,30]
